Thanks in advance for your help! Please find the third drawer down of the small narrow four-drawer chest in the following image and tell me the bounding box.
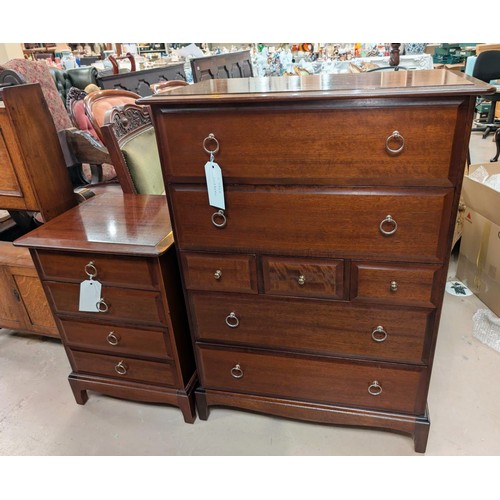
[61,319,172,359]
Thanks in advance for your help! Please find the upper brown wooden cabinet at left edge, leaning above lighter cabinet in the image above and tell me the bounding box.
[0,84,77,221]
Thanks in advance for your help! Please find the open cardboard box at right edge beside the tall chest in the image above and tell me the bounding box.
[457,163,500,316]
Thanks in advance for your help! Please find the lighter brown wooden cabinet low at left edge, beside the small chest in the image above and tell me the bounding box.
[0,241,59,337]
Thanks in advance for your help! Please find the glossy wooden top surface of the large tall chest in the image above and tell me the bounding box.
[138,69,494,106]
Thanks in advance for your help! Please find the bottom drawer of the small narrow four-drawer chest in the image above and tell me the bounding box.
[70,350,176,386]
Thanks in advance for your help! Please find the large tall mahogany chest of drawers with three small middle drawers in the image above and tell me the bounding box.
[143,70,492,452]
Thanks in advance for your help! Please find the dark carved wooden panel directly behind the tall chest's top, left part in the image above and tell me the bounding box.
[190,50,253,83]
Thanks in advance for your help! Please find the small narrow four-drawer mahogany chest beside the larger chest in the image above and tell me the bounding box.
[15,193,196,423]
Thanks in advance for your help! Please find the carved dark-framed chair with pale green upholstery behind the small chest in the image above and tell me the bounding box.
[101,104,165,194]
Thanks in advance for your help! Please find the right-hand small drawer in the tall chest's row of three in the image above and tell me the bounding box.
[351,262,443,307]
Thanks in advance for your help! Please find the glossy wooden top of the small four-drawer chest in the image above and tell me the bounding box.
[15,193,173,256]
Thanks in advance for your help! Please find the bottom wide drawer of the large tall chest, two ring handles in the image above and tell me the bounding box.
[198,347,426,414]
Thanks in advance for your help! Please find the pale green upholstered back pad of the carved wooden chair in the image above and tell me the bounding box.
[121,127,165,194]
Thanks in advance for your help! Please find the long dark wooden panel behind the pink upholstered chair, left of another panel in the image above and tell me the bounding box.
[97,63,186,97]
